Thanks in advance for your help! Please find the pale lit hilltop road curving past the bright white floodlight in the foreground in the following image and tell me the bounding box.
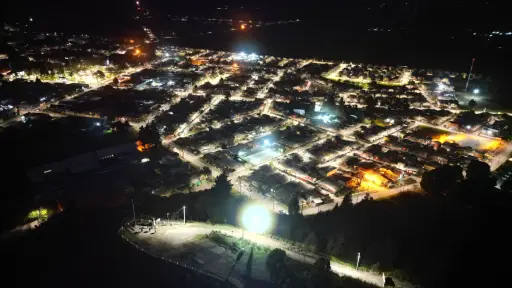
[123,223,412,287]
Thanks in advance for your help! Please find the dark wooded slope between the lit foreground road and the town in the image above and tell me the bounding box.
[280,161,512,287]
